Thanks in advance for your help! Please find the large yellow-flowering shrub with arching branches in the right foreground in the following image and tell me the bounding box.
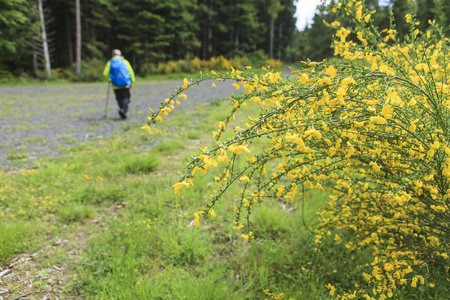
[148,0,450,299]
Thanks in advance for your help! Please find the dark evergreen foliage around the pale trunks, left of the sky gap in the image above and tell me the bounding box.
[0,0,295,75]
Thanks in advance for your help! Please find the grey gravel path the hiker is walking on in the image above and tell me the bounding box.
[0,80,236,171]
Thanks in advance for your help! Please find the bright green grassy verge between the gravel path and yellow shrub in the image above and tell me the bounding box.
[0,96,370,299]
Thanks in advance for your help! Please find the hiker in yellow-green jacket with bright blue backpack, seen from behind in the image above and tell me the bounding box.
[103,49,136,119]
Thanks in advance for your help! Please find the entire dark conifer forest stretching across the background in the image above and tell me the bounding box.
[0,0,450,78]
